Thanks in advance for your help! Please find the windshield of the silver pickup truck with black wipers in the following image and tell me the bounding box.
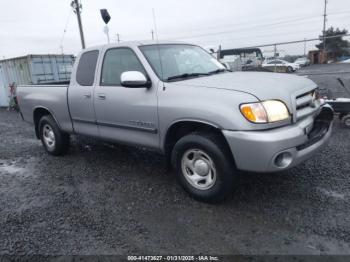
[140,44,226,81]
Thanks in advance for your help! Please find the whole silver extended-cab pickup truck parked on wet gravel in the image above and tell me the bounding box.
[17,42,333,202]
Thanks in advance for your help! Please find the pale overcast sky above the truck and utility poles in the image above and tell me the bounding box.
[0,0,350,58]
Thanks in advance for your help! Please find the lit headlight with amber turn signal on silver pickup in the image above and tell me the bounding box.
[240,100,289,123]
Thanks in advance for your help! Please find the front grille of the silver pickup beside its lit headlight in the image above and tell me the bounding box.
[295,90,320,120]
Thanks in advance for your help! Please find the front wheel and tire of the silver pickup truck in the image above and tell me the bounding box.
[171,133,237,203]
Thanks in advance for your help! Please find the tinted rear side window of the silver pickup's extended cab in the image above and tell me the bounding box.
[76,50,98,86]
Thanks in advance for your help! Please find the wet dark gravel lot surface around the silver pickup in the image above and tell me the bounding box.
[0,63,350,255]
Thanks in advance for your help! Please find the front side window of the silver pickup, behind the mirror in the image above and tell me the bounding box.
[101,48,146,86]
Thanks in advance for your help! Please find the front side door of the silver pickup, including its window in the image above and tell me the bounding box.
[94,47,159,148]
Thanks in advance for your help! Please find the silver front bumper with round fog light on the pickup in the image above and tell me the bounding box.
[223,105,333,172]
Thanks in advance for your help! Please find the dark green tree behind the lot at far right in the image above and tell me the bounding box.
[316,27,350,57]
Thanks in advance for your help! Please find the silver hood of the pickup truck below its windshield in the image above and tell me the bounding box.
[171,72,317,109]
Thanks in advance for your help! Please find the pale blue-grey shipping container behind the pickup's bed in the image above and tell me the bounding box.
[0,55,74,106]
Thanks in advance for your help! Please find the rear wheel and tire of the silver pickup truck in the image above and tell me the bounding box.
[39,115,69,156]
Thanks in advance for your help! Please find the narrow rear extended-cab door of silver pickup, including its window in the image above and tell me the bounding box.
[68,49,100,137]
